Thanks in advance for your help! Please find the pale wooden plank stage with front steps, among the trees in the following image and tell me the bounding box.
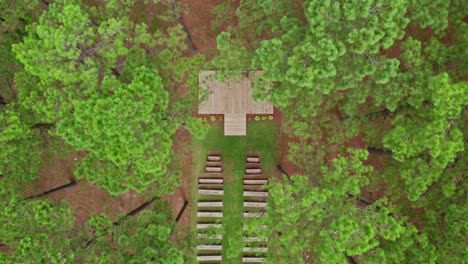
[198,71,273,136]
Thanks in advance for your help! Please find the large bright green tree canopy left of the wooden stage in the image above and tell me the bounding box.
[13,0,207,195]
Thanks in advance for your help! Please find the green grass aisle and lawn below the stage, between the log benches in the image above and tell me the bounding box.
[191,121,279,263]
